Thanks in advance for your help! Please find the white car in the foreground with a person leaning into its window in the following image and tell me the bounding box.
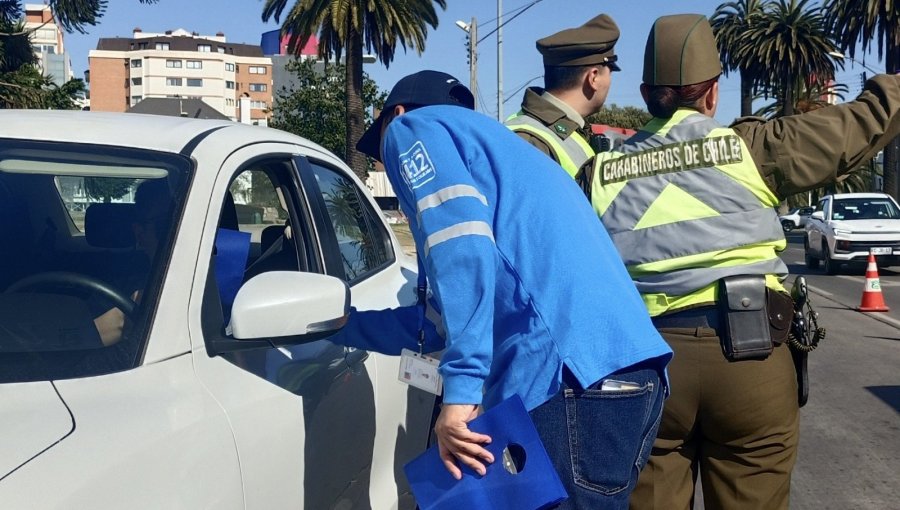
[0,111,434,510]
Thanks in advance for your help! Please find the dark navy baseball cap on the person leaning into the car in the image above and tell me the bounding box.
[356,71,475,161]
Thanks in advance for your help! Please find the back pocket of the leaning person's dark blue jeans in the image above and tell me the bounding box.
[565,383,653,495]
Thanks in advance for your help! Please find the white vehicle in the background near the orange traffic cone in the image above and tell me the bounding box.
[803,193,900,274]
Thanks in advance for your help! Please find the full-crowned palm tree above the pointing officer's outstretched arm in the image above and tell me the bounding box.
[737,0,835,115]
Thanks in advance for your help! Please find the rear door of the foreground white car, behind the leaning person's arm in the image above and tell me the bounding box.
[297,156,435,508]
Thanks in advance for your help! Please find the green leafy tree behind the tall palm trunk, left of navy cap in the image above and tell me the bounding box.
[269,60,387,167]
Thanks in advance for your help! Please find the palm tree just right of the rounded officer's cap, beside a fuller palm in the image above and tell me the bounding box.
[710,0,763,117]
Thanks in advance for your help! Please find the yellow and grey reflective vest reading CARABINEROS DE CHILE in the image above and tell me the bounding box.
[591,109,787,316]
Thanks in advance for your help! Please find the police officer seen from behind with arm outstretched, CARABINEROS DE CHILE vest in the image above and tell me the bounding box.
[585,14,900,509]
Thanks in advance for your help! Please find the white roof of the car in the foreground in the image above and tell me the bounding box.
[0,110,327,153]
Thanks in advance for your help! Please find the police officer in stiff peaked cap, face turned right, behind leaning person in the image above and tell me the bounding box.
[506,14,619,177]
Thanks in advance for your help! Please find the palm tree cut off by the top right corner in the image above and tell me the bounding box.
[825,0,900,198]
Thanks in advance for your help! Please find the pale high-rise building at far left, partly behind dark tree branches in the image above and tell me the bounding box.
[25,4,74,85]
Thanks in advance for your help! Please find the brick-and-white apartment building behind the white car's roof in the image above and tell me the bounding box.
[88,28,273,125]
